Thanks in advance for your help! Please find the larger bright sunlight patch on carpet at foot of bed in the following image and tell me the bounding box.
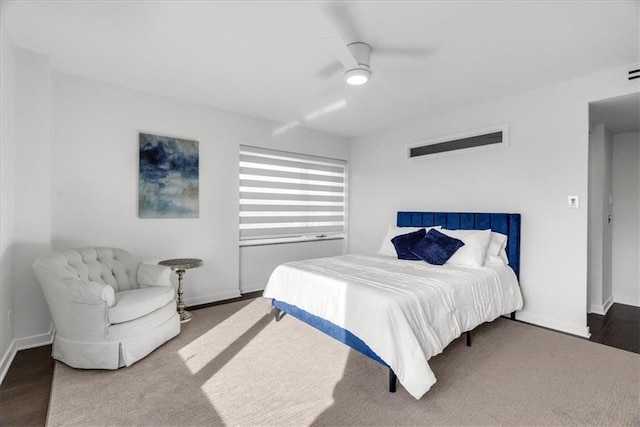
[201,316,350,425]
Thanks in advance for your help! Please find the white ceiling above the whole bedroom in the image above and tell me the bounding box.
[2,0,640,136]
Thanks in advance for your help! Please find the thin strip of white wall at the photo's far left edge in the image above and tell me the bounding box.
[0,13,15,379]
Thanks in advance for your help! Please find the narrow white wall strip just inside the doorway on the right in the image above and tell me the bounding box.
[587,124,613,314]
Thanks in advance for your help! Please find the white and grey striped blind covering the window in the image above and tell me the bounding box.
[240,145,347,245]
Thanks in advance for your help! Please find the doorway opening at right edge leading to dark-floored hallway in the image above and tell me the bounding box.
[586,93,640,352]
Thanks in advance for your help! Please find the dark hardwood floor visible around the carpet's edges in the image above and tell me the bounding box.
[0,302,640,426]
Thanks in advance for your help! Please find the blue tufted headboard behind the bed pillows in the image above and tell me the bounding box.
[397,211,521,279]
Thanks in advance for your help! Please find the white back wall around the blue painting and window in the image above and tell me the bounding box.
[50,73,349,304]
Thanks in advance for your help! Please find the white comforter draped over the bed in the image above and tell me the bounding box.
[263,255,522,399]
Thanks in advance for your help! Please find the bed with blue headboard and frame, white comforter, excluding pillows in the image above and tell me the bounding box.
[263,211,522,399]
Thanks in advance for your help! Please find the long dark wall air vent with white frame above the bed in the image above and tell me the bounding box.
[407,123,509,159]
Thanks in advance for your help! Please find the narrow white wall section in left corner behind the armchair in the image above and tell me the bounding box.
[13,49,51,344]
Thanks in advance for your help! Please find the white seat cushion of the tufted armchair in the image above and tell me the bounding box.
[108,286,174,325]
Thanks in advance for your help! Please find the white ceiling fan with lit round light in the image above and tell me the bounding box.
[318,2,428,85]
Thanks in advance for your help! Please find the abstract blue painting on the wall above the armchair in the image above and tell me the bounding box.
[138,133,199,218]
